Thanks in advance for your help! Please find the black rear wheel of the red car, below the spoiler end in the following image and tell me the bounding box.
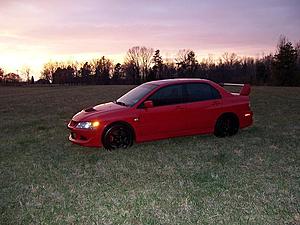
[214,114,239,137]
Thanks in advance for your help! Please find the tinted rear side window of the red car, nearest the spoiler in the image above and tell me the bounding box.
[186,83,221,102]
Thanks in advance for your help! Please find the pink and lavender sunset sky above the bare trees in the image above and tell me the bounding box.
[0,0,300,77]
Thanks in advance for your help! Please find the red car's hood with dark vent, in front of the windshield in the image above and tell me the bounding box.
[72,102,127,122]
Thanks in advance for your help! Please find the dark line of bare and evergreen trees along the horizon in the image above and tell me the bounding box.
[0,37,300,86]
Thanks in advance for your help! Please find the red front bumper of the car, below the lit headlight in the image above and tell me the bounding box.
[68,121,102,147]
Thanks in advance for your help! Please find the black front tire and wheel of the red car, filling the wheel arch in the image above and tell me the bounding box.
[102,124,133,150]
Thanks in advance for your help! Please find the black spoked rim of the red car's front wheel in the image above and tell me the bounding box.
[105,127,131,150]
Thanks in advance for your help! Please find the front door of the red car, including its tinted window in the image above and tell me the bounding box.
[138,84,187,140]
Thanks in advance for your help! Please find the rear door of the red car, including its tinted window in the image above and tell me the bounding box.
[185,83,222,133]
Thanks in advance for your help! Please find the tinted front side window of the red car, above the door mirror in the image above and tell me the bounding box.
[149,85,182,106]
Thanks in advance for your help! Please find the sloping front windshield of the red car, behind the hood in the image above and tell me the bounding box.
[115,84,157,106]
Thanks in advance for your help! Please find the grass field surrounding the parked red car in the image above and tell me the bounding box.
[0,86,300,224]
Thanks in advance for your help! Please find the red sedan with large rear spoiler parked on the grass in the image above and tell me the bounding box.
[68,79,253,150]
